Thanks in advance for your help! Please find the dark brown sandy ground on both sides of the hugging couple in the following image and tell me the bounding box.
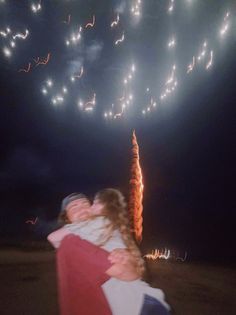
[0,250,236,315]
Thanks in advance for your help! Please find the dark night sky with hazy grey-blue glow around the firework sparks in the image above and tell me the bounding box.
[0,0,236,260]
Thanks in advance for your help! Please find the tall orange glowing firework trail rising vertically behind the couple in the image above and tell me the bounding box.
[129,131,143,243]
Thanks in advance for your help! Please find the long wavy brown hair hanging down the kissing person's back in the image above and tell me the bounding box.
[95,188,145,276]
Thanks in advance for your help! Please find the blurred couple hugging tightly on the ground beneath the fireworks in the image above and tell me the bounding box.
[48,188,170,315]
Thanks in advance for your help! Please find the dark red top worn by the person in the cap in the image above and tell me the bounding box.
[57,234,112,315]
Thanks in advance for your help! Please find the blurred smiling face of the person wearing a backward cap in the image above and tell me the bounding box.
[66,198,91,223]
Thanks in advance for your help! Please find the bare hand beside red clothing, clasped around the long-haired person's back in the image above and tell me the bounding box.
[106,248,141,281]
